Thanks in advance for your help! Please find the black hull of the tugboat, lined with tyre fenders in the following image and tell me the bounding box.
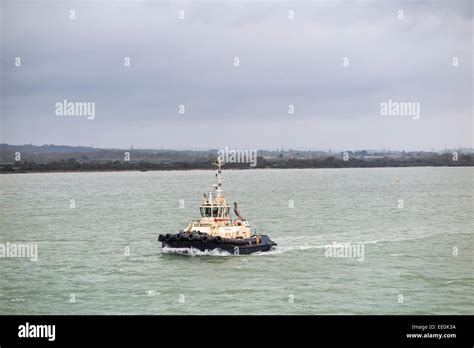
[158,234,277,255]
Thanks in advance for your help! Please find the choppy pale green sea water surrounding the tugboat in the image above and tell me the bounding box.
[0,168,474,314]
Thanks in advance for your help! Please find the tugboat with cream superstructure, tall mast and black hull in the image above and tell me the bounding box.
[158,156,277,255]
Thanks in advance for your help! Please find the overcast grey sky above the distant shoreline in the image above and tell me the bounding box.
[0,0,474,150]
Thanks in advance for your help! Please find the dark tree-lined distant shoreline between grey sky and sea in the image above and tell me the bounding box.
[0,144,474,174]
